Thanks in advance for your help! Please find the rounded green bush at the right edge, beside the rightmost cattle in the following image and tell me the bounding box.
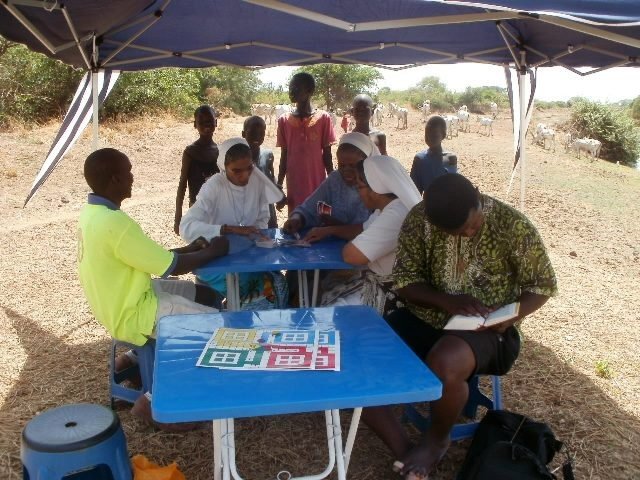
[571,100,640,166]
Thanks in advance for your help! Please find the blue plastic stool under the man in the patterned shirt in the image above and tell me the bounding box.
[404,375,502,441]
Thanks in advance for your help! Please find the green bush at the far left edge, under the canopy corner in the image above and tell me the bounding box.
[0,38,83,124]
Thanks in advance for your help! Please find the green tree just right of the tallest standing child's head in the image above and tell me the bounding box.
[294,63,382,109]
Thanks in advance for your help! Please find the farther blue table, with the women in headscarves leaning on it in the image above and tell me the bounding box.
[194,228,355,310]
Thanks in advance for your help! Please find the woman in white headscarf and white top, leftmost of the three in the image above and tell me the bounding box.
[180,137,287,309]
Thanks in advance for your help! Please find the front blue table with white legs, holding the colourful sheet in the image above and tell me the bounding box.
[152,306,442,480]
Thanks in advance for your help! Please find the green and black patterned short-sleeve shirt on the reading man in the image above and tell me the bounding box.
[393,195,557,328]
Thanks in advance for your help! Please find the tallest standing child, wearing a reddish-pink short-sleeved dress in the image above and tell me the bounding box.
[276,72,336,215]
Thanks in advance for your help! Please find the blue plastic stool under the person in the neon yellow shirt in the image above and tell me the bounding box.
[109,339,156,408]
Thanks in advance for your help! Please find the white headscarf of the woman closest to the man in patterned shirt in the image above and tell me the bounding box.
[364,155,422,210]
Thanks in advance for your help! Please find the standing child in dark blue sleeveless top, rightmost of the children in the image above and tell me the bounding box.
[411,115,458,195]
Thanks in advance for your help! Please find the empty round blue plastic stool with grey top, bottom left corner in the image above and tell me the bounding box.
[20,403,133,480]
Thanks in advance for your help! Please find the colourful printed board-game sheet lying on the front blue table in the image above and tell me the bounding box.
[196,327,340,371]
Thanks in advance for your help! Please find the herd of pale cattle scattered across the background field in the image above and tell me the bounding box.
[251,100,602,159]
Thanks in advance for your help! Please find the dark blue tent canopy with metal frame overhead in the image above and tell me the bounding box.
[0,0,640,71]
